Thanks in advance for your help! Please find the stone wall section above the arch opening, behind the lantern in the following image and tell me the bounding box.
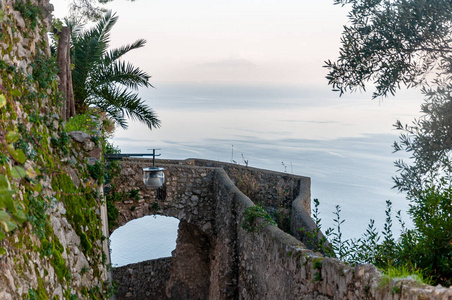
[110,159,215,233]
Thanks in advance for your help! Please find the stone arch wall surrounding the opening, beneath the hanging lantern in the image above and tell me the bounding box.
[107,160,215,299]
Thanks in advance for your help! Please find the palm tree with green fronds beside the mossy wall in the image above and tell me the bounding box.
[68,11,160,129]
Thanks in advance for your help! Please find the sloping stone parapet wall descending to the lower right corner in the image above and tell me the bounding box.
[211,170,452,299]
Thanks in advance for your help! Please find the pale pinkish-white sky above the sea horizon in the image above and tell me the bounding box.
[51,0,347,85]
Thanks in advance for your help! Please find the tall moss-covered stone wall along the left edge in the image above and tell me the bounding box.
[0,0,109,299]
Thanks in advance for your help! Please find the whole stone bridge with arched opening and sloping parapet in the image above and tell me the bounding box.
[107,159,452,299]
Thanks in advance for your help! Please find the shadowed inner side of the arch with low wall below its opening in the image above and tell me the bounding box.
[113,213,215,300]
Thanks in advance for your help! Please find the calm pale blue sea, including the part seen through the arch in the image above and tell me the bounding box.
[111,83,422,266]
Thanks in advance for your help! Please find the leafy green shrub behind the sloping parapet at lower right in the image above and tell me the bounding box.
[320,195,452,286]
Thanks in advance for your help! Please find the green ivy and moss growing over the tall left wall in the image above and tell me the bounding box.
[0,1,111,299]
